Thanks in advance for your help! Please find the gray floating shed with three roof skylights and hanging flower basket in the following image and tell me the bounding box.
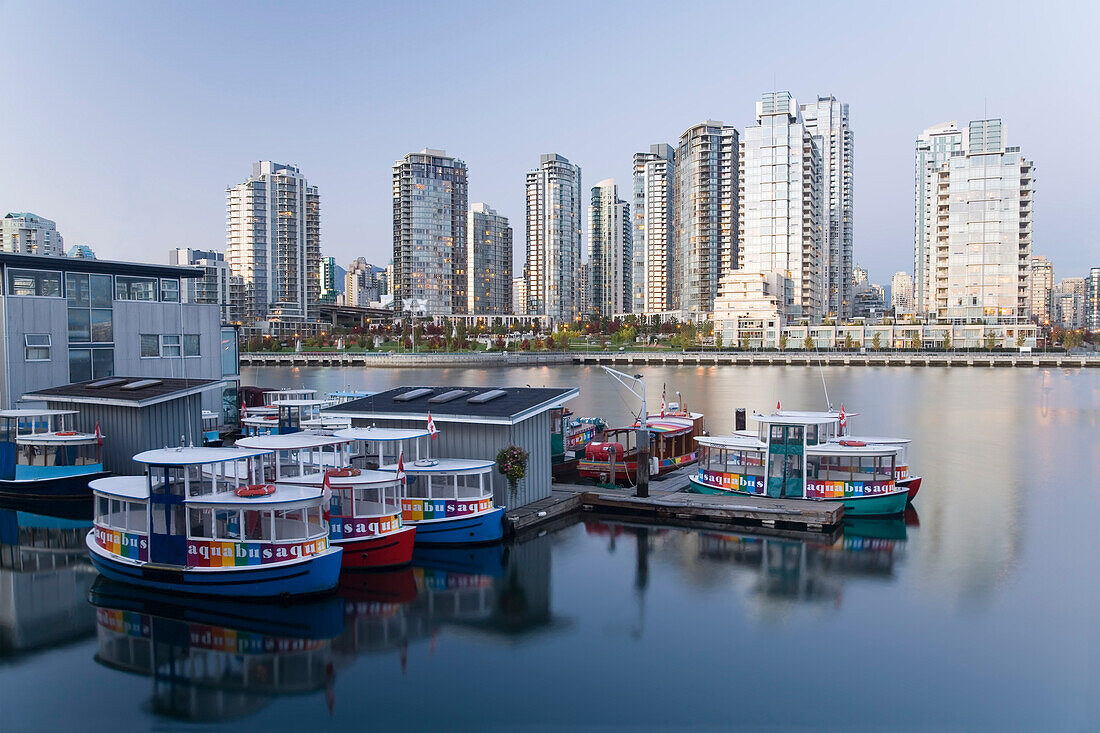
[321,386,580,508]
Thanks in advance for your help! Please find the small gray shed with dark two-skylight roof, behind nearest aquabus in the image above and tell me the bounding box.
[26,376,222,474]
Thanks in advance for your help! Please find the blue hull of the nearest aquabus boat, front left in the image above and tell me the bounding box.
[86,532,343,599]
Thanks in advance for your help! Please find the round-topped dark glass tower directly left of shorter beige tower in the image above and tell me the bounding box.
[394,149,469,316]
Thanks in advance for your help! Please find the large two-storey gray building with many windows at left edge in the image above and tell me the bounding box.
[0,253,240,422]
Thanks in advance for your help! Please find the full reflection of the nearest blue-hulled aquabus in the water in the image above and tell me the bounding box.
[89,578,343,721]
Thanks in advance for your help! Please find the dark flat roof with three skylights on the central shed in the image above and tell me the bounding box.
[321,385,580,425]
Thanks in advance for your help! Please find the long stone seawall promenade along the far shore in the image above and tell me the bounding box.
[241,350,1100,369]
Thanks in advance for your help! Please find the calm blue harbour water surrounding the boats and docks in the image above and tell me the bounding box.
[0,368,1100,731]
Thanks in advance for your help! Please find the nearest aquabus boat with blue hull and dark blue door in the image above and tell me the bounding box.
[86,447,341,599]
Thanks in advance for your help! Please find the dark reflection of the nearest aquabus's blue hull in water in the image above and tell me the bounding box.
[88,577,343,638]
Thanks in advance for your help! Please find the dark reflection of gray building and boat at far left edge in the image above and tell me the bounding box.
[0,510,96,657]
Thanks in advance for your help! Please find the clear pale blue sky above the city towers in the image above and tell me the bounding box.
[0,0,1100,282]
